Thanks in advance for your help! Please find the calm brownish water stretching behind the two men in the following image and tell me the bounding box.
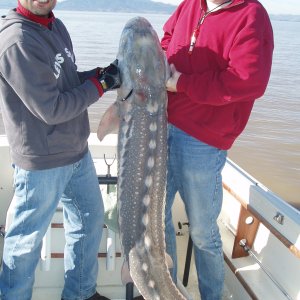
[0,10,300,209]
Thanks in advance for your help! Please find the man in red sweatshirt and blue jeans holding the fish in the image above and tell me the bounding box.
[161,0,274,300]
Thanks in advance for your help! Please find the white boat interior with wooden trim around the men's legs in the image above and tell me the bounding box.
[0,135,300,300]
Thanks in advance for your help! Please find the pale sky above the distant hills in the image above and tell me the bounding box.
[152,0,300,15]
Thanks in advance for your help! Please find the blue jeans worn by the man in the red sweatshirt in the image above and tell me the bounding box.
[165,125,227,300]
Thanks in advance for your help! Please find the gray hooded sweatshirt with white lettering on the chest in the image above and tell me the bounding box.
[0,10,99,170]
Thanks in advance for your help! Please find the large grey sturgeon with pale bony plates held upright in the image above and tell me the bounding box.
[97,17,185,300]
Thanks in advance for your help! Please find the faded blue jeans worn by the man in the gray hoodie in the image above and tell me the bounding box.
[0,152,104,300]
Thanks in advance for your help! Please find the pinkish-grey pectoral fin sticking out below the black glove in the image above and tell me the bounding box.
[97,103,120,141]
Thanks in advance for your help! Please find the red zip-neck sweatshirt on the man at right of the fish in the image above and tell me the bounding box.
[161,0,274,150]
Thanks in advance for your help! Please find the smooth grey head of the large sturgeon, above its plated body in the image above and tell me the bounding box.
[117,17,168,115]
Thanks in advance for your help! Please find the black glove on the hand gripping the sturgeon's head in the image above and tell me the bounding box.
[98,59,121,92]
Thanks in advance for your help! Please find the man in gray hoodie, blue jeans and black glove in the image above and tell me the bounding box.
[0,0,120,300]
